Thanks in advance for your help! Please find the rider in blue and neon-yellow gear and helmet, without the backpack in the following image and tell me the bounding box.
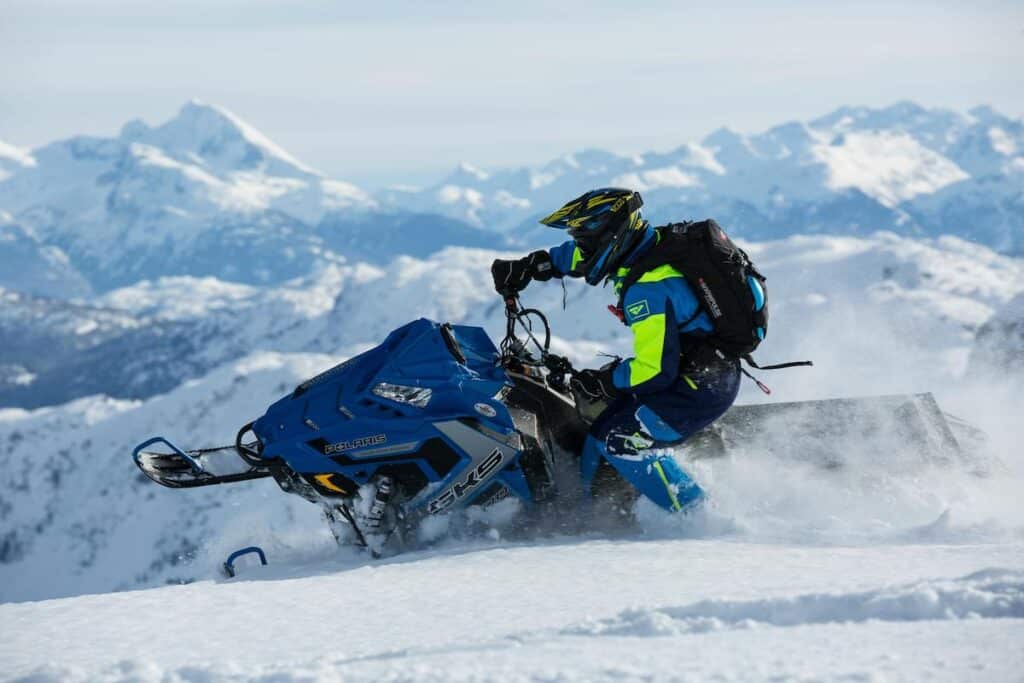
[490,187,739,510]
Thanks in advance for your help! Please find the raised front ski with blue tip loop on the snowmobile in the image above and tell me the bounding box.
[132,436,271,488]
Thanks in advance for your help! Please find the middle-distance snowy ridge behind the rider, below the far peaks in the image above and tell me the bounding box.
[6,227,1024,408]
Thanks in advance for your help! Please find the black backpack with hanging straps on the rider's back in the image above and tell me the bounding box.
[618,219,811,378]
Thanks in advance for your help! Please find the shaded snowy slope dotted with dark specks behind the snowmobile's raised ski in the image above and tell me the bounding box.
[0,354,330,599]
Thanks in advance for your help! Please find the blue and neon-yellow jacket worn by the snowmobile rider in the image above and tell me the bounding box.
[549,227,714,393]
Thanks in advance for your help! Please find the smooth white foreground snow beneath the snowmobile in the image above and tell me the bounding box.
[0,540,1024,681]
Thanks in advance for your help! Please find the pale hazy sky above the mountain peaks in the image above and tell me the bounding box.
[0,0,1024,187]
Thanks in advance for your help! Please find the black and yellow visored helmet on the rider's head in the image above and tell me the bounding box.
[541,187,647,285]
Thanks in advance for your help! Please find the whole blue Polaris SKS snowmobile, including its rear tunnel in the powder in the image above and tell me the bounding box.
[133,299,986,555]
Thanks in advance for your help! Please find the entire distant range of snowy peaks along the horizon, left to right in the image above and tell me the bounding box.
[0,101,1024,298]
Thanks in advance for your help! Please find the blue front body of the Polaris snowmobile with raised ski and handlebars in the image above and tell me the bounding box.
[133,299,633,554]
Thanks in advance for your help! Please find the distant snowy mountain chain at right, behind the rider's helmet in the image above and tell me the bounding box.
[377,102,1024,253]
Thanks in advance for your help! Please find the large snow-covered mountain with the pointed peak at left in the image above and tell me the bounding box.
[0,101,494,296]
